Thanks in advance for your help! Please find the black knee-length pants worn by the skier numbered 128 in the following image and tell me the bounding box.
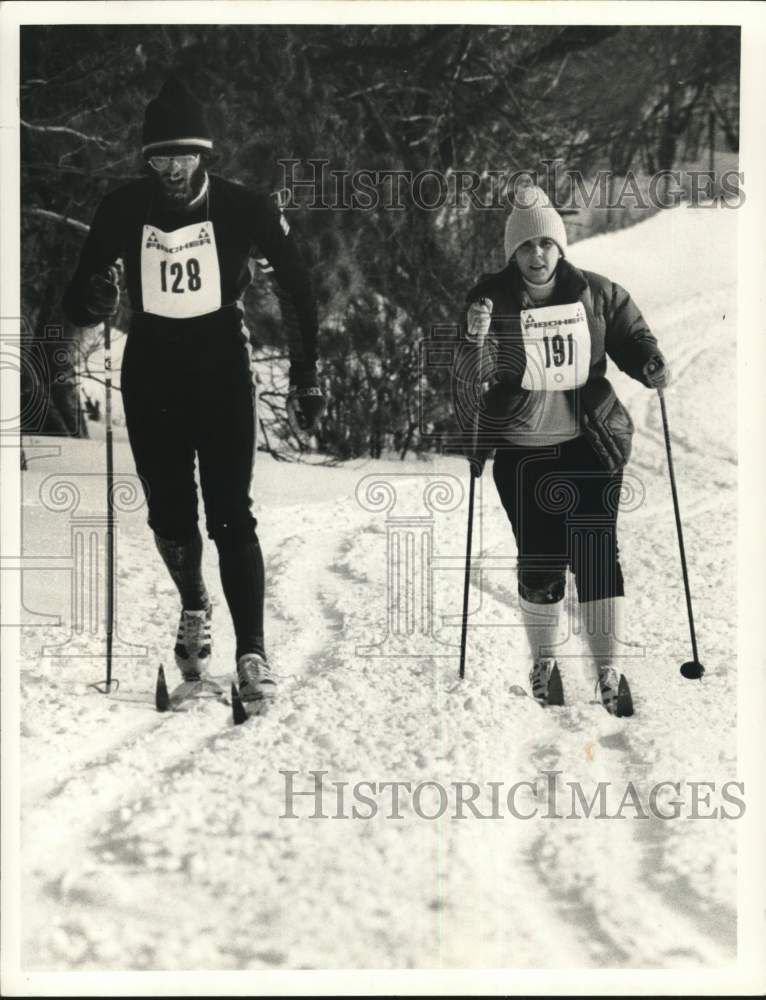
[121,323,256,540]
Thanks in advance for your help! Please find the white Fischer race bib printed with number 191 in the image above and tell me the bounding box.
[521,302,590,392]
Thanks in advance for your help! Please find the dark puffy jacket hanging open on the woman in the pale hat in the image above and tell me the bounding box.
[467,259,662,470]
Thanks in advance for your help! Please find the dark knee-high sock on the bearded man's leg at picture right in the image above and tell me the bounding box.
[216,538,266,659]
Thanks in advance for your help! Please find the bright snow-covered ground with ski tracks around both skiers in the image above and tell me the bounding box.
[16,209,737,970]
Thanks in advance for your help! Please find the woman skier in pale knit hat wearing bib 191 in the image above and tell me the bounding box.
[467,186,669,716]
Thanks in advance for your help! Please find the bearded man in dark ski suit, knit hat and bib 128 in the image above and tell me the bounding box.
[63,79,323,705]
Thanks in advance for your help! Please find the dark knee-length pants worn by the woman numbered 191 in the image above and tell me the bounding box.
[493,437,625,604]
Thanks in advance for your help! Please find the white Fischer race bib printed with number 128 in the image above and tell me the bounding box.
[141,221,221,319]
